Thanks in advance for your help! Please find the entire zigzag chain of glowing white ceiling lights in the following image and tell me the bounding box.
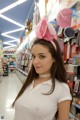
[0,0,27,48]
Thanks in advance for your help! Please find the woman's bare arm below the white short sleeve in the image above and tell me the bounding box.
[58,100,71,120]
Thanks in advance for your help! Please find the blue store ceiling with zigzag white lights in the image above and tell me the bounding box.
[0,0,38,48]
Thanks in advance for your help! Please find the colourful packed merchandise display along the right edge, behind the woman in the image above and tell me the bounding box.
[57,3,80,120]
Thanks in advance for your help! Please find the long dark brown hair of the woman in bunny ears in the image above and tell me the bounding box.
[13,38,66,106]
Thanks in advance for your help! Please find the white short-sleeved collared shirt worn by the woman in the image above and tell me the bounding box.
[15,80,72,120]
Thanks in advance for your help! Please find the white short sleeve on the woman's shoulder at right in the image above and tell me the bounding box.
[58,83,72,103]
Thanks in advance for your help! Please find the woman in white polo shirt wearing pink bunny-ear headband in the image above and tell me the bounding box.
[13,20,71,120]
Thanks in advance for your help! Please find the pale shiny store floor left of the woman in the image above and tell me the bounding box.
[0,73,22,120]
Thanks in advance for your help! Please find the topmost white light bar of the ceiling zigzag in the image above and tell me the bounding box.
[0,0,27,13]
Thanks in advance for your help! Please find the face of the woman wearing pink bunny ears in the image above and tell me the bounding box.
[31,44,55,74]
